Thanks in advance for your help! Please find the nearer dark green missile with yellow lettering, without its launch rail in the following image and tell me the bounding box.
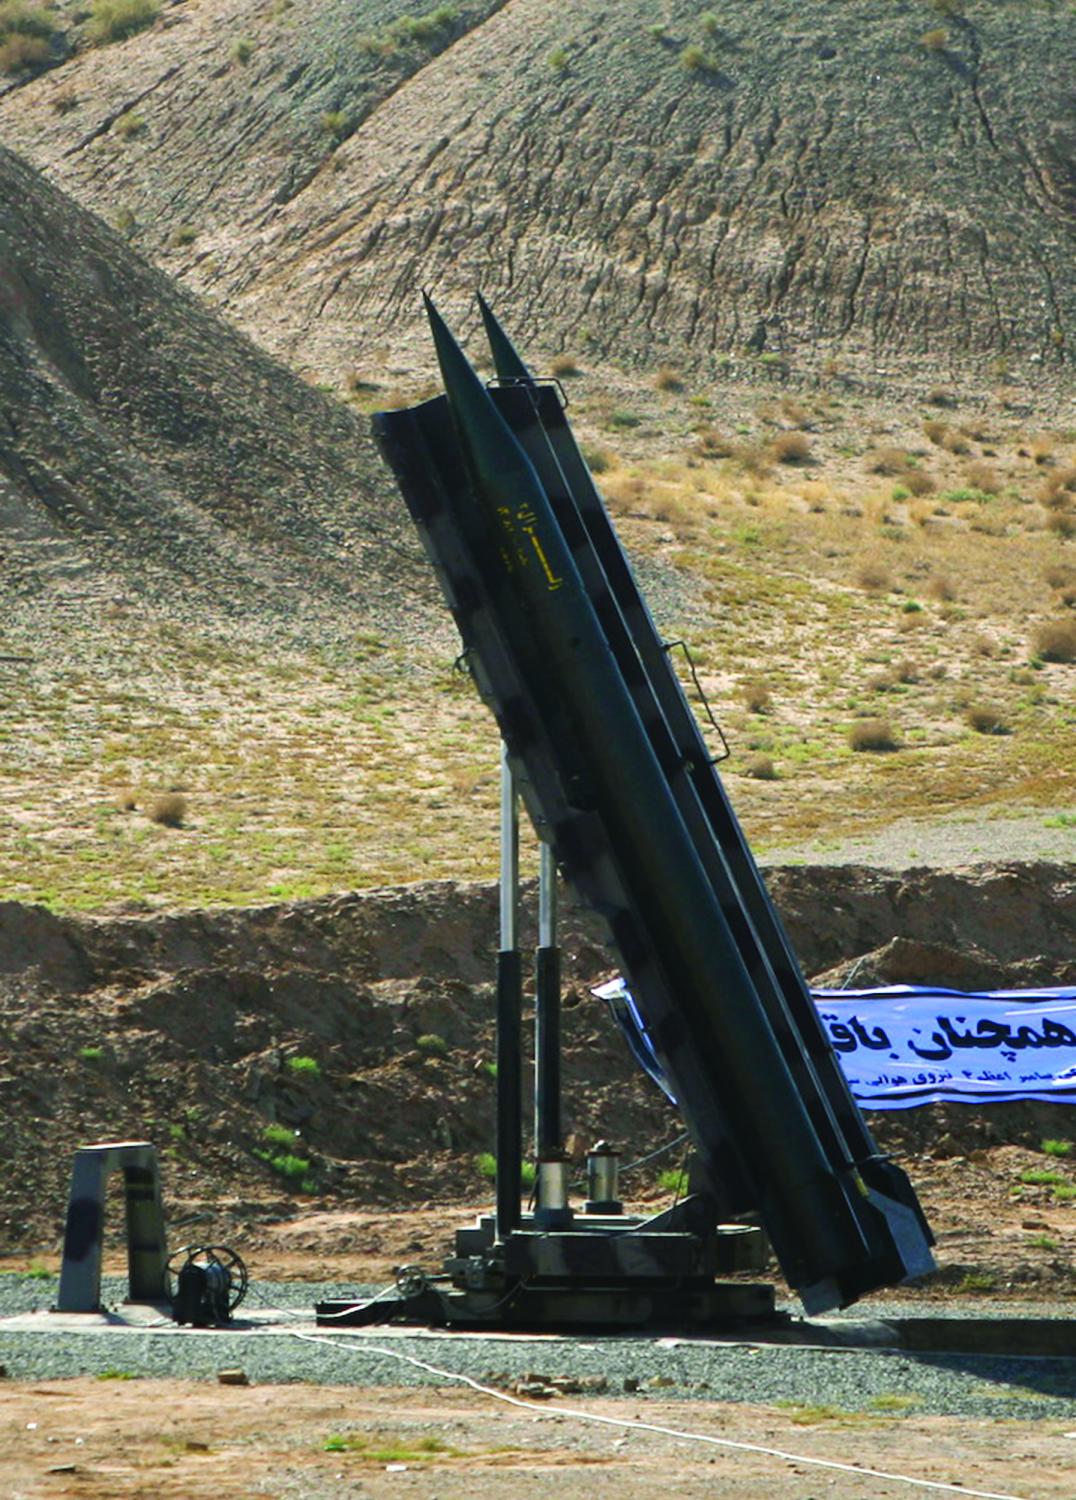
[426,302,905,1308]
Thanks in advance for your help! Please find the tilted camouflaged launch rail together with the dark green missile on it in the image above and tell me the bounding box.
[375,306,930,1311]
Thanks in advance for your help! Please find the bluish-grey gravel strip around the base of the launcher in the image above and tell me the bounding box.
[0,1275,1076,1422]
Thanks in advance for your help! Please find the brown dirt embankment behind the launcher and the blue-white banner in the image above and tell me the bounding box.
[0,866,1076,1280]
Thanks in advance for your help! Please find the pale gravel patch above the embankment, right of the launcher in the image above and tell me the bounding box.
[761,807,1076,870]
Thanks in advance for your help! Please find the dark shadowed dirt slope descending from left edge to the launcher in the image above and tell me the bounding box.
[0,150,432,639]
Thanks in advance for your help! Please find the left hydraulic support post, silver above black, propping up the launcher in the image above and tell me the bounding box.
[497,744,522,1241]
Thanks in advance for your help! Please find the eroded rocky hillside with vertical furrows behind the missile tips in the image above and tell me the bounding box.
[0,0,1076,395]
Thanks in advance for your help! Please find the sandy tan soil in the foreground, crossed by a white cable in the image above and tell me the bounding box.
[0,1380,1076,1500]
